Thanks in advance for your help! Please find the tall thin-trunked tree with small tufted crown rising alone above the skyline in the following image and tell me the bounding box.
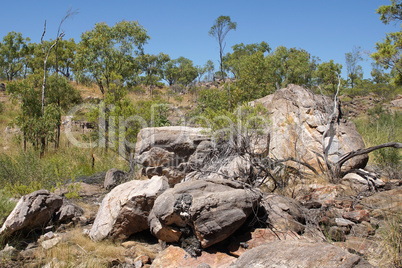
[209,16,237,79]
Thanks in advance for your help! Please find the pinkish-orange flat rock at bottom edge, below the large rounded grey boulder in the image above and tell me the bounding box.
[151,246,236,268]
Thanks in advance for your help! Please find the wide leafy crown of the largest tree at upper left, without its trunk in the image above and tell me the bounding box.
[75,21,149,94]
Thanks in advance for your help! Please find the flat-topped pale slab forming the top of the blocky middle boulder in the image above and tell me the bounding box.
[135,126,209,162]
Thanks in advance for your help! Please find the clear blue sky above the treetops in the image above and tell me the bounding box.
[0,0,400,78]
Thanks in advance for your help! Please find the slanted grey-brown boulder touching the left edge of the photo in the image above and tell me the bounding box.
[0,190,63,236]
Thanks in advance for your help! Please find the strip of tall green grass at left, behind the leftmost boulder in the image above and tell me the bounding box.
[0,147,125,196]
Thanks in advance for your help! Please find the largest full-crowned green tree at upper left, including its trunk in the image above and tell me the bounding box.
[75,21,150,151]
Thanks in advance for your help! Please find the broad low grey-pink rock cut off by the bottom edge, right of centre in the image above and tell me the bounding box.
[230,240,373,268]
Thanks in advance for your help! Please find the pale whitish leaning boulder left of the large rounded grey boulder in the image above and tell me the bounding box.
[89,176,168,241]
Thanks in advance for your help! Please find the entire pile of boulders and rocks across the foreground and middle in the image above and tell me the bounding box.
[0,85,402,267]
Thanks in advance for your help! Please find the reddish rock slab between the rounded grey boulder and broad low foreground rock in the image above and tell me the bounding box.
[228,229,300,257]
